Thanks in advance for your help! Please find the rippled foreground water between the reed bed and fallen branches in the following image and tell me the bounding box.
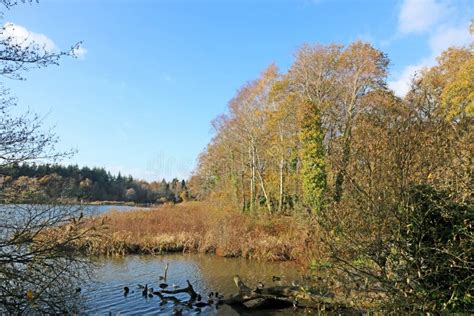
[83,254,299,315]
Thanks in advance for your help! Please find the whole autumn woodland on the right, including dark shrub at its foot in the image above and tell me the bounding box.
[190,41,474,311]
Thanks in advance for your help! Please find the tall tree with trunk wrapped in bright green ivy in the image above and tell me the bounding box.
[288,45,342,209]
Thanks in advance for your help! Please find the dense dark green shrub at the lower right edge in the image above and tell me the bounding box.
[392,185,474,311]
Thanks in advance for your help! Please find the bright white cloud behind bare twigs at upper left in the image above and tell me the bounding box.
[0,22,58,52]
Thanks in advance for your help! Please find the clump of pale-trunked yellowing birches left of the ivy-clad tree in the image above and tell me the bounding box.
[194,65,279,213]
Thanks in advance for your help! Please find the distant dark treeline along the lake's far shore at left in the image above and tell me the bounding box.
[0,164,188,203]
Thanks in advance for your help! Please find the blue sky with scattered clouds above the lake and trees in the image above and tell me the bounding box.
[2,0,474,180]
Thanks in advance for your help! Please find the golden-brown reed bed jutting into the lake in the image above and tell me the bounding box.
[82,202,317,262]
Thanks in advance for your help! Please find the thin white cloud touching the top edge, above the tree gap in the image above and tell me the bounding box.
[398,0,448,34]
